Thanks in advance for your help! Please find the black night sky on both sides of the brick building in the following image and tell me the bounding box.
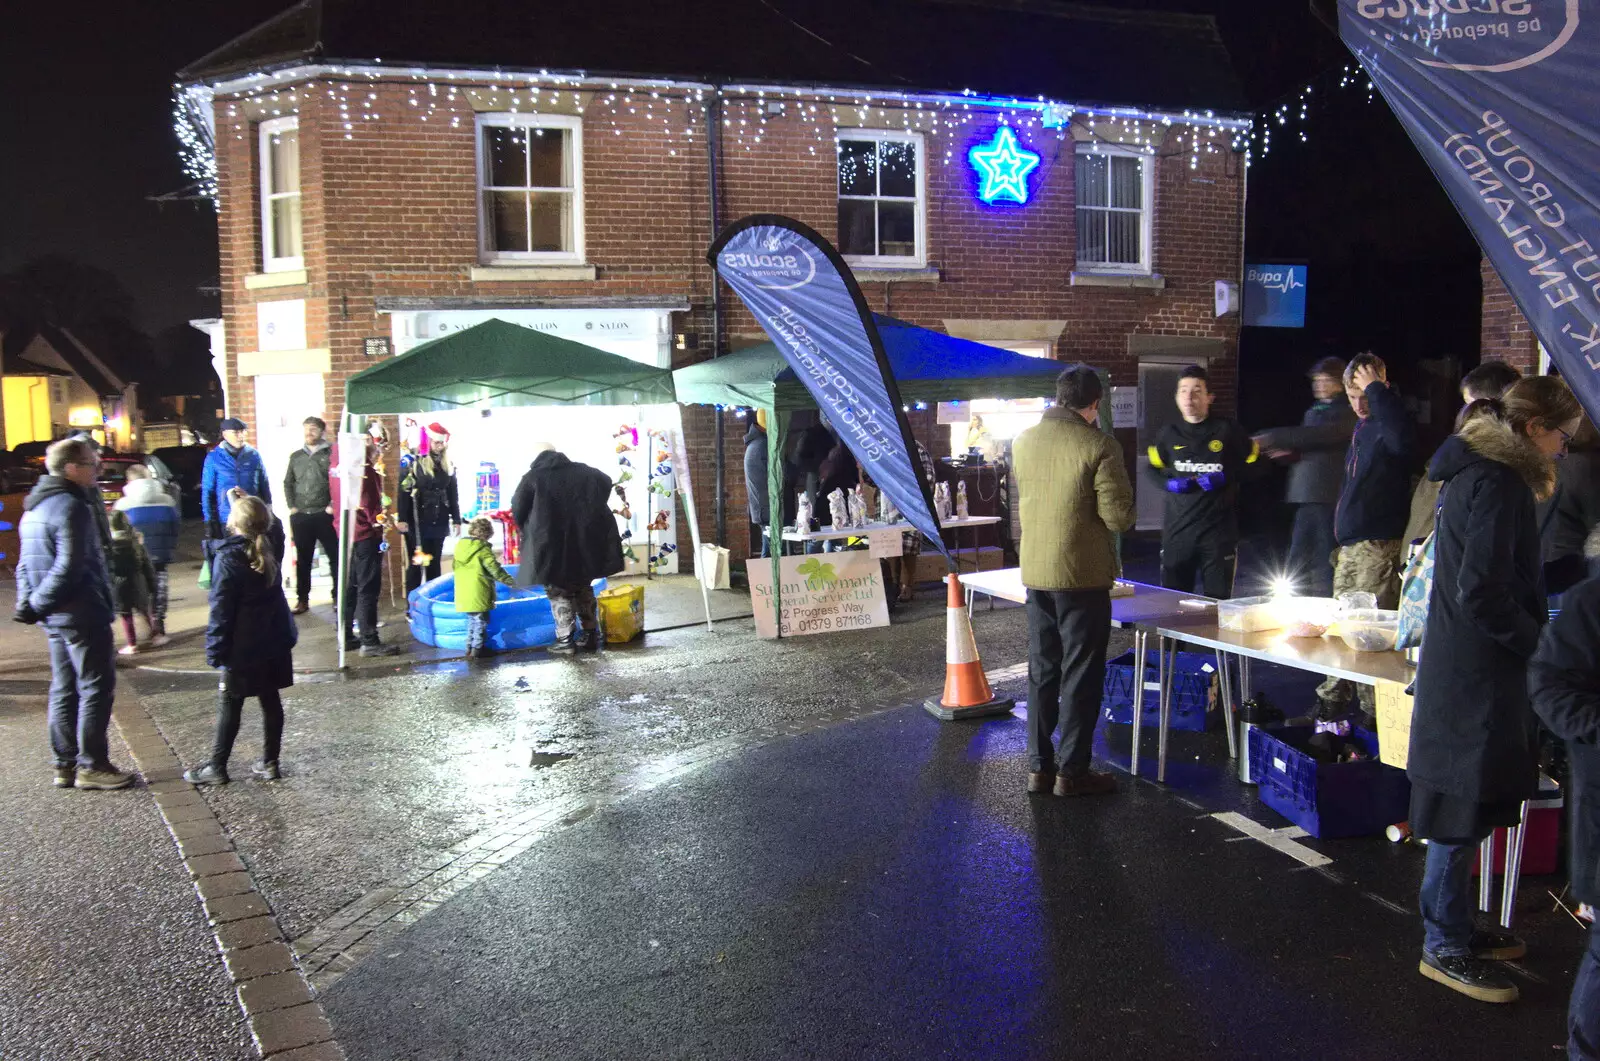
[0,0,1477,385]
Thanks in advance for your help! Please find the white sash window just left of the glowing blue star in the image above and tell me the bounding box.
[838,130,928,267]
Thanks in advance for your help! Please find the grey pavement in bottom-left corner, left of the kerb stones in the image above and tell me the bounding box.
[0,665,256,1061]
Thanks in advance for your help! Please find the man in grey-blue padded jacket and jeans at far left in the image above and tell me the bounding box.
[13,438,133,789]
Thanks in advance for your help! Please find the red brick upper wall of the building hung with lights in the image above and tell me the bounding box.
[206,80,1243,569]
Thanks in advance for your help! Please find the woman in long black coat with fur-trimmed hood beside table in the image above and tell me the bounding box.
[1406,376,1582,1002]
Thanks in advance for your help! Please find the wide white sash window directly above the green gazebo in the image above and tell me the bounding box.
[478,114,584,262]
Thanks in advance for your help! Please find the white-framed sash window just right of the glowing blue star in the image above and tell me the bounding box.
[1077,149,1152,272]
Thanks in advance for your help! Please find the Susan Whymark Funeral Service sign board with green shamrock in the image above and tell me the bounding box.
[746,550,899,637]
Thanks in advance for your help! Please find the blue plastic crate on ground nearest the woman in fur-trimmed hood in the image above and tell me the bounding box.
[1250,727,1411,840]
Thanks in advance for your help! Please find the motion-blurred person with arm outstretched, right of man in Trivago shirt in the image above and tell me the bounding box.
[1256,357,1355,597]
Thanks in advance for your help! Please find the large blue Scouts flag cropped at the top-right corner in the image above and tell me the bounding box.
[1339,0,1600,418]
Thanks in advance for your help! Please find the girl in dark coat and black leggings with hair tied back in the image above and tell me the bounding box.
[184,496,299,784]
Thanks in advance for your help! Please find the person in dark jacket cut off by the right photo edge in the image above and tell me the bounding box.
[1528,569,1600,1061]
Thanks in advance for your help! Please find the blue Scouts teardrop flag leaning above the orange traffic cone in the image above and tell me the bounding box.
[706,214,954,570]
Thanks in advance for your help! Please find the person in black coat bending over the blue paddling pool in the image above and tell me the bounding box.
[510,446,624,653]
